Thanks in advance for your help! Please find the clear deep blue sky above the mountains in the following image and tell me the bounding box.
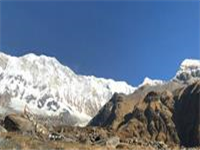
[0,0,200,86]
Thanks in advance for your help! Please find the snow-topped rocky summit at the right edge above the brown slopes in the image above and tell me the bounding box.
[174,59,200,83]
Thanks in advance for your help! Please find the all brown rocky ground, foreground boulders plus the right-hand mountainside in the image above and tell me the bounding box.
[0,80,200,150]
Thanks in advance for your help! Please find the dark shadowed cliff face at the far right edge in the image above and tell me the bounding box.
[174,82,200,146]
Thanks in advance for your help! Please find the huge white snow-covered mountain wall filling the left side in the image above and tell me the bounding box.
[0,53,135,124]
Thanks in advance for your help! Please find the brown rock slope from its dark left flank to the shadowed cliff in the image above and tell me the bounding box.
[90,90,179,143]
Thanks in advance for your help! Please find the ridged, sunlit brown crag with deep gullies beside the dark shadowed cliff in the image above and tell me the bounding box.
[118,91,179,144]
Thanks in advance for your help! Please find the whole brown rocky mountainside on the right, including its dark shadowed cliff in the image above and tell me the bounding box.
[89,81,200,146]
